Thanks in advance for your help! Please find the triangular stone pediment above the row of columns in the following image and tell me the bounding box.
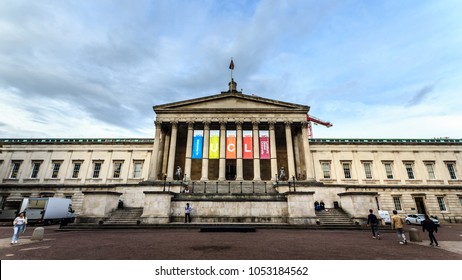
[154,93,309,112]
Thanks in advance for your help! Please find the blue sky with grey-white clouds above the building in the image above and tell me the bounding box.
[0,0,462,138]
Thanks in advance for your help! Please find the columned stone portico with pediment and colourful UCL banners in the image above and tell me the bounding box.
[150,81,313,181]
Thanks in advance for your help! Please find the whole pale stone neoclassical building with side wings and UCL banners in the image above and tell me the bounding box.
[0,80,462,224]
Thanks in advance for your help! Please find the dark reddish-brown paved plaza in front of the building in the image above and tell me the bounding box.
[0,224,462,260]
